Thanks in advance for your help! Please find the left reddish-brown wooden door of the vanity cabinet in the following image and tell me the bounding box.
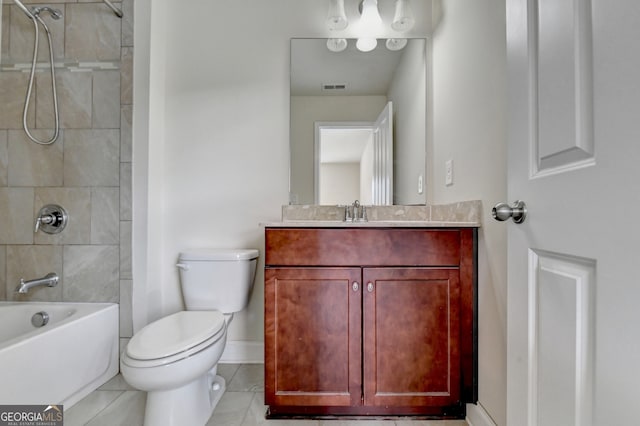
[265,267,362,406]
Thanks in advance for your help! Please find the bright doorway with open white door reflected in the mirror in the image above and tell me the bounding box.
[314,102,393,205]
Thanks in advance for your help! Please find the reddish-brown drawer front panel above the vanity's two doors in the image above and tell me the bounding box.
[265,228,464,266]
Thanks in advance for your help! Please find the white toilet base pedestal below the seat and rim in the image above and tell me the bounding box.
[144,369,226,426]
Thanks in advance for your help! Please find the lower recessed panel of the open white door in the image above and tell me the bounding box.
[528,250,595,426]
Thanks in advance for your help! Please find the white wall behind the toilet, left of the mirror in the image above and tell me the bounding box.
[133,0,430,358]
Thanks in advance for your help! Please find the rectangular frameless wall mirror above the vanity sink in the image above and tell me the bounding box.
[289,39,427,205]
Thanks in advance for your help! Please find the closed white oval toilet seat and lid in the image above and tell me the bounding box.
[125,311,226,367]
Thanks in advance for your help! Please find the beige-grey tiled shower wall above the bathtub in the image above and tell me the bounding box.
[0,0,133,337]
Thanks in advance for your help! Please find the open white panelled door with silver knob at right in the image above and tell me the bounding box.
[505,0,640,426]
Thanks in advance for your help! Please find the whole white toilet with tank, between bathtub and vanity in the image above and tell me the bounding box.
[120,249,258,426]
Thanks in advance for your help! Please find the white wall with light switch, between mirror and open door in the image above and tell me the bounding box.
[428,0,508,426]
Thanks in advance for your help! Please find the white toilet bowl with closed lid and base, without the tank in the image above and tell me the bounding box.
[120,311,227,426]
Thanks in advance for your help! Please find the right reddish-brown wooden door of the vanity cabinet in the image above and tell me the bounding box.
[363,268,460,407]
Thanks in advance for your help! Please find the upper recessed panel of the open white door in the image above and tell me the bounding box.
[527,0,594,177]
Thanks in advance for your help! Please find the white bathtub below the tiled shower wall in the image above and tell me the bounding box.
[0,302,119,409]
